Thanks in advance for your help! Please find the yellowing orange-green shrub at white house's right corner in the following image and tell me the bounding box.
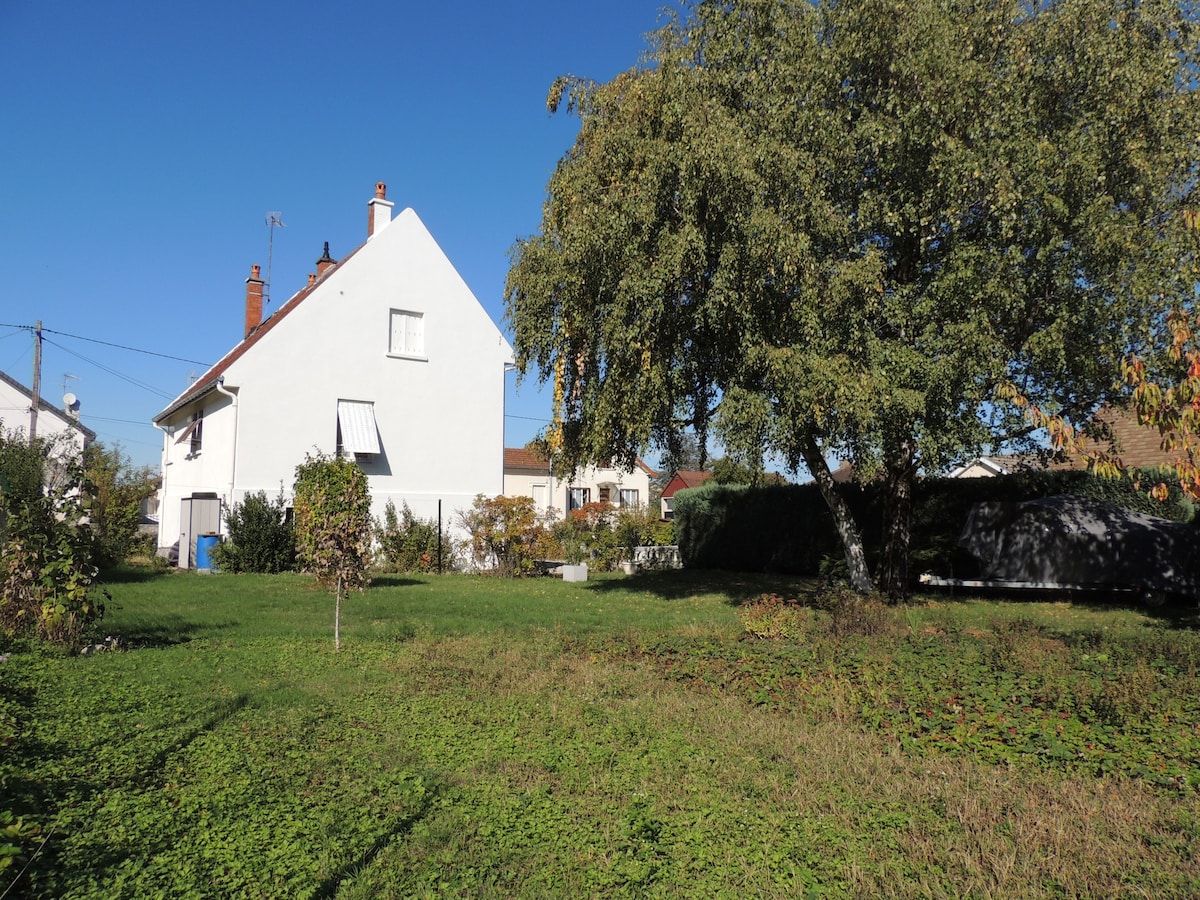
[458,494,554,578]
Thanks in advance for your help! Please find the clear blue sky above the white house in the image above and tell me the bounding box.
[0,0,668,467]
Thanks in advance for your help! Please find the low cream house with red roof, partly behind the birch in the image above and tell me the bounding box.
[504,448,656,518]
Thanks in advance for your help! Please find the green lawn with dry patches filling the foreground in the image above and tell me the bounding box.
[0,570,1200,898]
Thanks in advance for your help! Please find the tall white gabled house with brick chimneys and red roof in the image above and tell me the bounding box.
[154,182,512,565]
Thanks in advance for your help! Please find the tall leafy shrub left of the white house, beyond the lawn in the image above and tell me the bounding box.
[84,442,158,566]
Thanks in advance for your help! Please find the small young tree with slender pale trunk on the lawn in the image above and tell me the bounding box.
[295,452,371,649]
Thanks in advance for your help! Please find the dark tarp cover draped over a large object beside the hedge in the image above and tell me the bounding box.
[959,497,1200,598]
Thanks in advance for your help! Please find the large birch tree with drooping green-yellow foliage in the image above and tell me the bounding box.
[506,0,1200,602]
